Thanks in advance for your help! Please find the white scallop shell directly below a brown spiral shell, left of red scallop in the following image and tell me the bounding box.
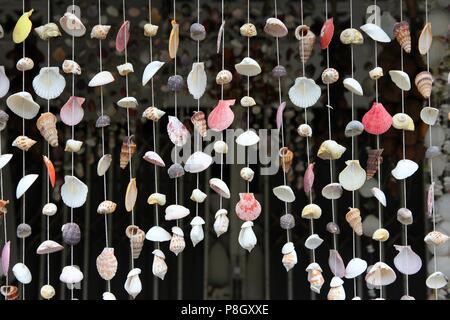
[289,77,321,109]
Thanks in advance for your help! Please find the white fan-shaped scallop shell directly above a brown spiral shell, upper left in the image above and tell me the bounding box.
[33,67,66,100]
